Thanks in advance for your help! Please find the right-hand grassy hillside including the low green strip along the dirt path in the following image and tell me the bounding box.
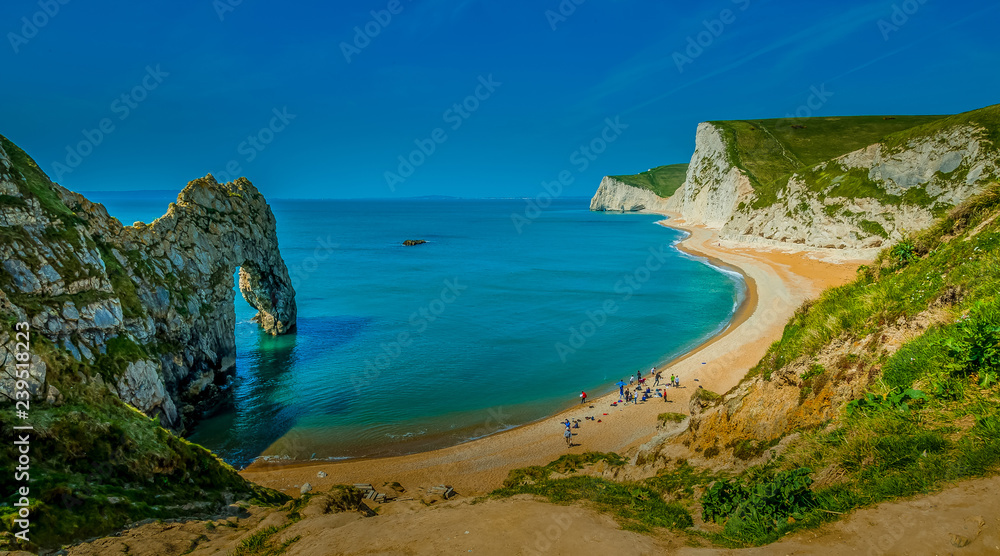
[495,185,1000,546]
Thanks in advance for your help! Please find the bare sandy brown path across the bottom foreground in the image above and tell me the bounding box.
[64,477,1000,556]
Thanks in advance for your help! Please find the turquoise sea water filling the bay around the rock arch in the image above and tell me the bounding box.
[88,192,744,467]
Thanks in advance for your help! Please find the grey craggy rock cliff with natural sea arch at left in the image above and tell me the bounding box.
[0,138,296,429]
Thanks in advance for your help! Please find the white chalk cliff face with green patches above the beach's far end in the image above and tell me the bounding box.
[668,117,1000,254]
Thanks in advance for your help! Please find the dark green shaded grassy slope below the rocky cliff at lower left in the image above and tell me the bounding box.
[0,137,285,550]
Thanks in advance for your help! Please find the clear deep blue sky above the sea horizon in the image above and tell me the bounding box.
[0,0,1000,198]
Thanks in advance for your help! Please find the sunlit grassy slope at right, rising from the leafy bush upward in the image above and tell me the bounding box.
[712,185,1000,545]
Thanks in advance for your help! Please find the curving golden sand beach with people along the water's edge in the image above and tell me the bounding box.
[241,215,865,495]
